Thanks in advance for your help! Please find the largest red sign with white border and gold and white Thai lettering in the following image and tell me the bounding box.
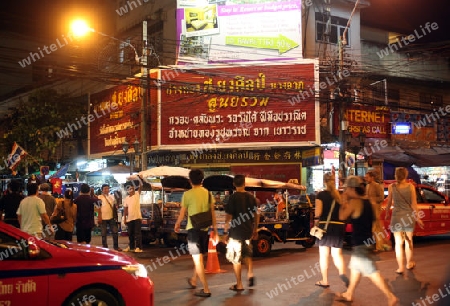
[159,60,320,151]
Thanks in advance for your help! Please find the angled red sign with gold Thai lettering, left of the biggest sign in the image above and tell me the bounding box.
[89,85,149,154]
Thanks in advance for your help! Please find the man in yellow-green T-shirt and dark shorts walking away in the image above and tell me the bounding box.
[174,169,218,297]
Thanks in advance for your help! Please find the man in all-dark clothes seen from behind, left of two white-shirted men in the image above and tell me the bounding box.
[73,184,99,244]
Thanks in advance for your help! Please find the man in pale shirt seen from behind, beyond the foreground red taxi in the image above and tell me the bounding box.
[17,183,53,239]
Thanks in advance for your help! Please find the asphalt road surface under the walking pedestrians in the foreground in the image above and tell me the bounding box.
[93,236,450,306]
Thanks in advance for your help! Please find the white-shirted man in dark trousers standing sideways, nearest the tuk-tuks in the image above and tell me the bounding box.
[123,183,142,253]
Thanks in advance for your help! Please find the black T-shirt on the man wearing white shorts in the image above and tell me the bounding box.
[225,192,258,240]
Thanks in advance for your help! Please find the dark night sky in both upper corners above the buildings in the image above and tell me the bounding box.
[0,0,450,42]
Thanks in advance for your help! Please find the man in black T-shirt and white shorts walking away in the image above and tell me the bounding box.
[225,175,259,291]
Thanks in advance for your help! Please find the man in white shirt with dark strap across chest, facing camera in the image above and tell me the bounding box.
[98,184,122,252]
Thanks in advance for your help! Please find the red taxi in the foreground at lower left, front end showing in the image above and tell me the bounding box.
[0,222,153,306]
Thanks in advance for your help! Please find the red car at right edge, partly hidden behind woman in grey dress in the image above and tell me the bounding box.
[380,180,450,236]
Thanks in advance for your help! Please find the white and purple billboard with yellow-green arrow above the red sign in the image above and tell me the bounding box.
[177,0,302,64]
